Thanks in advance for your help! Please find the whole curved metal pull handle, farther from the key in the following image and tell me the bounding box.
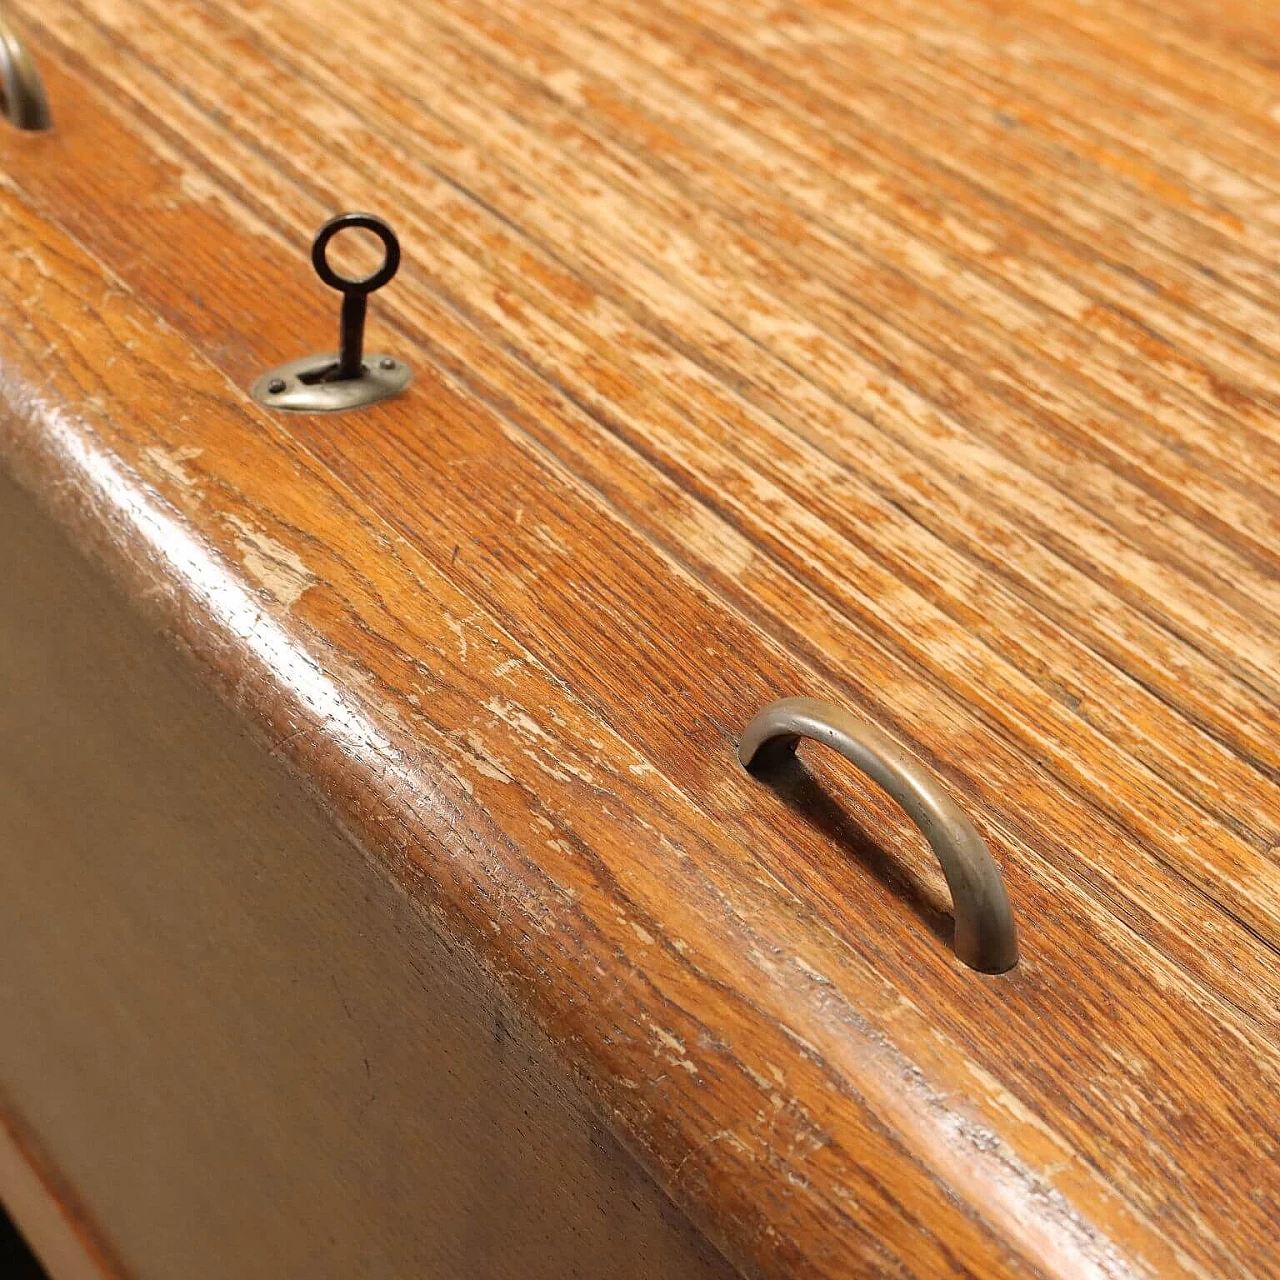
[737,698,1018,973]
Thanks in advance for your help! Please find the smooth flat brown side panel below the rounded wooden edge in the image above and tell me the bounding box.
[0,475,730,1280]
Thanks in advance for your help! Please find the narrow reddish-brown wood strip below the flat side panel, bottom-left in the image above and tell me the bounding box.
[0,1098,131,1280]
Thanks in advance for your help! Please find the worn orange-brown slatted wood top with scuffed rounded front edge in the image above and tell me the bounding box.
[0,0,1280,1277]
